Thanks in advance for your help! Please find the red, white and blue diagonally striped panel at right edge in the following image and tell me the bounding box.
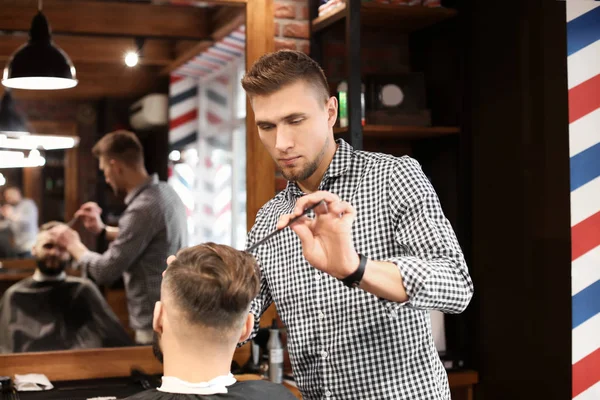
[566,0,600,400]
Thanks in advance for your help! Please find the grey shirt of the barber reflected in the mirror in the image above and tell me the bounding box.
[79,174,187,330]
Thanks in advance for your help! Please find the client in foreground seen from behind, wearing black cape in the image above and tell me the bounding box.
[128,243,295,400]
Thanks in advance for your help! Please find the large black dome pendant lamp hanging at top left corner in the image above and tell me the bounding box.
[2,0,77,90]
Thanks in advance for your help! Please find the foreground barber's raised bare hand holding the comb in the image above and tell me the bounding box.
[277,191,360,279]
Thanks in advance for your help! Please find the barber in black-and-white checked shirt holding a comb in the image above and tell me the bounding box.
[242,50,473,400]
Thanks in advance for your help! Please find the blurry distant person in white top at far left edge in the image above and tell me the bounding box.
[0,186,38,258]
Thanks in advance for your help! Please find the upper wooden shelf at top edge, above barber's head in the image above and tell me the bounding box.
[311,2,456,33]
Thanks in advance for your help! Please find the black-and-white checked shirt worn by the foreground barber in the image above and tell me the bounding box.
[247,140,473,400]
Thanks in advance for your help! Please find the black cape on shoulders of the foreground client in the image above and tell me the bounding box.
[126,381,296,400]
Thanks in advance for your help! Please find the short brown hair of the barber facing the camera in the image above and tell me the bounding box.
[242,50,329,102]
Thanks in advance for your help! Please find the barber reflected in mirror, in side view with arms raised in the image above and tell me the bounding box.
[52,130,187,344]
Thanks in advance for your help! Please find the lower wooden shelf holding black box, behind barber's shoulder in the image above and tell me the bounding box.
[333,125,460,140]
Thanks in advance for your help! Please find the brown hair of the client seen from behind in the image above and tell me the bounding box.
[163,243,260,329]
